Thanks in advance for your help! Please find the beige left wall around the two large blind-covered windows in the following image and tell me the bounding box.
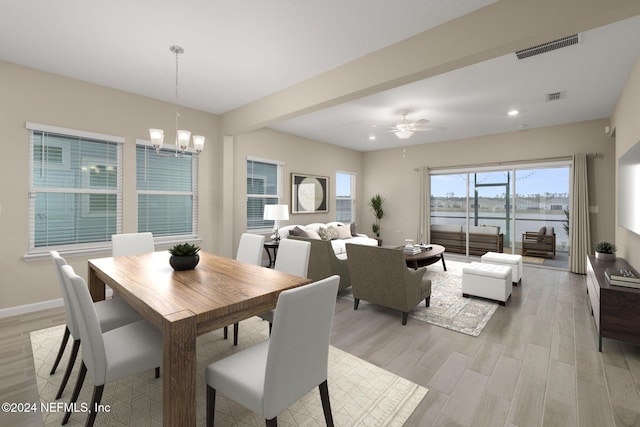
[0,62,221,309]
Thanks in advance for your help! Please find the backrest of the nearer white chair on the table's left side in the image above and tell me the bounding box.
[62,265,107,385]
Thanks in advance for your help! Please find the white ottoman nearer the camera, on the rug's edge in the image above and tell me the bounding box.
[462,262,512,305]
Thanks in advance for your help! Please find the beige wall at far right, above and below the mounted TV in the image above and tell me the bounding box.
[611,59,640,270]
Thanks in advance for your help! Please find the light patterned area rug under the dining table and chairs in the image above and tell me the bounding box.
[31,318,427,427]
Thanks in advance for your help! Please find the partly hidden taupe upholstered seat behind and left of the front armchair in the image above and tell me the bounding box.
[288,235,351,291]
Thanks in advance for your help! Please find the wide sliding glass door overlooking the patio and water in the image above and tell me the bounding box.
[430,162,571,268]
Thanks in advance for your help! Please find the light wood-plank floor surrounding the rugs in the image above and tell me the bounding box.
[0,266,640,427]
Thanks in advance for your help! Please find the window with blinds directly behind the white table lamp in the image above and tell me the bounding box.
[247,158,282,231]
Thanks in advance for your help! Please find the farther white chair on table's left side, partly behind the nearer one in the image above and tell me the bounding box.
[49,251,142,399]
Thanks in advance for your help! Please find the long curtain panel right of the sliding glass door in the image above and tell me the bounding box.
[569,154,591,274]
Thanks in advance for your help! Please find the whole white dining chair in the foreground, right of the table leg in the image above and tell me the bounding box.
[205,276,340,427]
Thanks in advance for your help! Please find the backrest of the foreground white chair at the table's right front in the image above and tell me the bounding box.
[263,275,340,419]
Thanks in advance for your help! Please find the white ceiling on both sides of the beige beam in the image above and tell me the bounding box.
[0,0,640,151]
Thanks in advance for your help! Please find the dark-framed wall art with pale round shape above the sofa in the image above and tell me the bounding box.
[291,173,329,213]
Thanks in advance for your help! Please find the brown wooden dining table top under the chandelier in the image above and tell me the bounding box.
[89,251,310,334]
